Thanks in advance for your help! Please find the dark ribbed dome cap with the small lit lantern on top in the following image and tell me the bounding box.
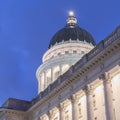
[49,12,96,48]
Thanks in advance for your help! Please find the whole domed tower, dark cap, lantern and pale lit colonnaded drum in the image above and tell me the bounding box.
[36,12,95,93]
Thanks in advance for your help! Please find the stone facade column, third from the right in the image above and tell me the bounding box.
[71,95,78,120]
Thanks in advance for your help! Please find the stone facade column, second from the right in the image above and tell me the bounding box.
[84,85,94,120]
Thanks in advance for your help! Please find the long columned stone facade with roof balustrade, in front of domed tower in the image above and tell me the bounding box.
[29,27,120,120]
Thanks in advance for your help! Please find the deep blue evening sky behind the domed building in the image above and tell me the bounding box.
[0,0,120,105]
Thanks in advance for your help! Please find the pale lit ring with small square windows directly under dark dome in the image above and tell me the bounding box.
[43,42,93,62]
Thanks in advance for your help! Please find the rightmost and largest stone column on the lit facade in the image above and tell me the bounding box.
[100,73,114,120]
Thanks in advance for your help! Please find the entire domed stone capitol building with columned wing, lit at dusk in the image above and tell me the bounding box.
[0,12,120,120]
